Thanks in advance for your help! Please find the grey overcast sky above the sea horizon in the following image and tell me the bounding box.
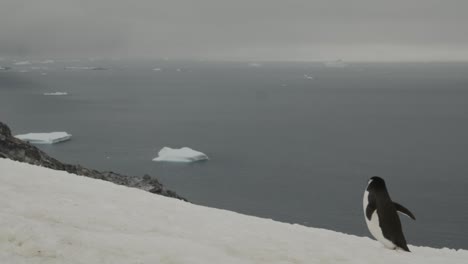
[0,0,468,61]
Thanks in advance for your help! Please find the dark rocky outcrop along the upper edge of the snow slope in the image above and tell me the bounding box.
[0,122,186,201]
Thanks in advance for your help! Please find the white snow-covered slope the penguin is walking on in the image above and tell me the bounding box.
[0,159,468,264]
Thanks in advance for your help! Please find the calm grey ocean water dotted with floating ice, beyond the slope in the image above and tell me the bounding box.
[0,60,468,249]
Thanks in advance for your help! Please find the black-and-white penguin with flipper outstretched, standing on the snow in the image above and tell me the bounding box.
[363,176,416,252]
